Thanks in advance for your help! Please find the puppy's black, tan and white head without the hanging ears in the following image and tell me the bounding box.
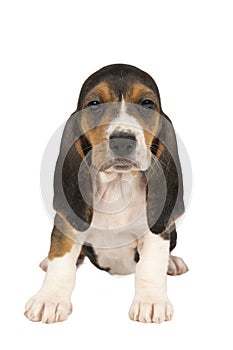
[78,65,161,172]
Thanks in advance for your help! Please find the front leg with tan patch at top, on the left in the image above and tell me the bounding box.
[25,227,81,323]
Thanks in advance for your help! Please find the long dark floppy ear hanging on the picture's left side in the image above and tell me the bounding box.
[53,111,93,231]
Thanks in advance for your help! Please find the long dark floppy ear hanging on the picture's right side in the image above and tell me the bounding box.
[146,114,184,234]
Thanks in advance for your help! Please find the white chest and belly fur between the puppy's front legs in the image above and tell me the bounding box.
[78,172,148,274]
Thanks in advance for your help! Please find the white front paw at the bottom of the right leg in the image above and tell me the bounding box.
[129,297,173,323]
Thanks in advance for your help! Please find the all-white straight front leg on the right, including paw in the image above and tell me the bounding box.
[129,232,173,323]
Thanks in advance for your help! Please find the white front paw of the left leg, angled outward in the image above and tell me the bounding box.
[24,291,72,323]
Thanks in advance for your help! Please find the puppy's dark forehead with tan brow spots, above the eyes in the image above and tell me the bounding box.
[78,65,160,109]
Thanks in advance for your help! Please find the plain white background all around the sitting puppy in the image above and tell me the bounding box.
[0,0,233,350]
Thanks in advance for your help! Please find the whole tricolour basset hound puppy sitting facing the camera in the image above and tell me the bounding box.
[25,65,187,323]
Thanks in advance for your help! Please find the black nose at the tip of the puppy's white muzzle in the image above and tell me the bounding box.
[109,132,136,157]
